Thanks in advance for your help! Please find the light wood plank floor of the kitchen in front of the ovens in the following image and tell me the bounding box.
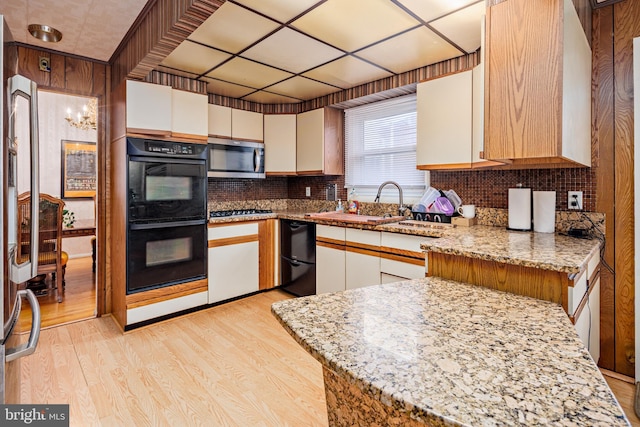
[21,291,640,427]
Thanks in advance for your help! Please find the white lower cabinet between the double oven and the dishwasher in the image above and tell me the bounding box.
[208,222,260,304]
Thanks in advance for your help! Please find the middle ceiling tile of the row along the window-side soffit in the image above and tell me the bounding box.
[303,56,392,89]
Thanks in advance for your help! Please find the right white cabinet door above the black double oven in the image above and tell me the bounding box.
[171,89,208,139]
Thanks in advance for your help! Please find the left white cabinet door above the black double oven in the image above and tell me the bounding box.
[126,80,172,136]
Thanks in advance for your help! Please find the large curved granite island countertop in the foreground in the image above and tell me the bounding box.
[271,278,630,426]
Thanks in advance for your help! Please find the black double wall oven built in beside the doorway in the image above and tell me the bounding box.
[126,138,207,294]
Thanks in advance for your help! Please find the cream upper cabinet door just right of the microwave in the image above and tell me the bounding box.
[264,114,296,175]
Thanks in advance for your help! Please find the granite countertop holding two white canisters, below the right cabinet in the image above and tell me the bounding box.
[420,225,600,274]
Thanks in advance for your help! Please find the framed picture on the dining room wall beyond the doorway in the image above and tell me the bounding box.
[60,139,98,199]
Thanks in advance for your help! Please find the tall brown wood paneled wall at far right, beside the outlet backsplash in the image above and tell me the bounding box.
[593,0,640,376]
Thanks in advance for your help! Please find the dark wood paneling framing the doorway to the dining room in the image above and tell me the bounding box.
[18,45,109,315]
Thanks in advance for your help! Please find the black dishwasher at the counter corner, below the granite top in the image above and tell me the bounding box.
[280,219,316,297]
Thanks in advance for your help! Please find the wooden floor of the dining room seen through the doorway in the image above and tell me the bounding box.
[17,257,96,332]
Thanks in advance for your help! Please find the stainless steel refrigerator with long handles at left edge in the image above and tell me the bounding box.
[0,15,40,403]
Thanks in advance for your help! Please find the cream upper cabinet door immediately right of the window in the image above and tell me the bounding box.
[416,70,473,169]
